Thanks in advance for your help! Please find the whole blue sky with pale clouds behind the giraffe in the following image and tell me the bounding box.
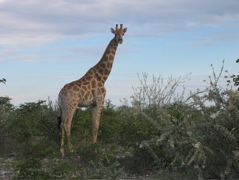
[0,0,239,106]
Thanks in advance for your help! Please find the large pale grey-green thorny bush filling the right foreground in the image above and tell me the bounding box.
[127,62,239,179]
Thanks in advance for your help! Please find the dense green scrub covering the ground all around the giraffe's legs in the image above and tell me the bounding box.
[0,61,239,179]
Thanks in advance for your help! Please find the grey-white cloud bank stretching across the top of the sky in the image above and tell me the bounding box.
[0,0,239,44]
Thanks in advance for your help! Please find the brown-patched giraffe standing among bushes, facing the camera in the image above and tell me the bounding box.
[58,24,127,158]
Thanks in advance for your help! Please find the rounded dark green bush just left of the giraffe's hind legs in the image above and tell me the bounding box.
[9,101,58,142]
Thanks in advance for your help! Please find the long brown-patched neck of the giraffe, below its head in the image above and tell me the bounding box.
[93,38,118,83]
